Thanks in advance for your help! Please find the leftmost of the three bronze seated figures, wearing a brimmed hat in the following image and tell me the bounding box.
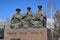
[11,8,22,28]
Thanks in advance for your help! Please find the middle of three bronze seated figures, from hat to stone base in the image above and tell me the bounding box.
[22,7,35,28]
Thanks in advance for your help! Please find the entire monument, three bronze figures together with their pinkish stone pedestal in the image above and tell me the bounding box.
[4,5,52,40]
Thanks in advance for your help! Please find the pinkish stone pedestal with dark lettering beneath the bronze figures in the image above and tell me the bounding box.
[4,28,52,40]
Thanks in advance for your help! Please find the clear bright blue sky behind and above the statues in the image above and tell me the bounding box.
[0,0,60,19]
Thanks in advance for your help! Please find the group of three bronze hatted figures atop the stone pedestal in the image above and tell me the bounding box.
[10,5,47,29]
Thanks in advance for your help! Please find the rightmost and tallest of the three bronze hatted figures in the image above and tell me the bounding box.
[36,5,46,27]
